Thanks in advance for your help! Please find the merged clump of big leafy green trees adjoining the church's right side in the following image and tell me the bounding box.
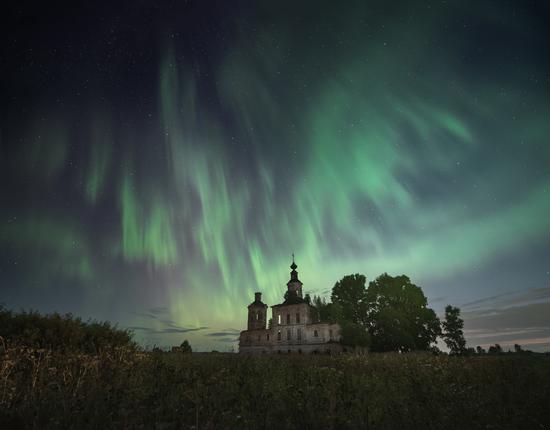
[313,273,441,352]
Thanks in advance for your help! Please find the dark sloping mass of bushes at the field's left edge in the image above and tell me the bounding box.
[0,306,137,353]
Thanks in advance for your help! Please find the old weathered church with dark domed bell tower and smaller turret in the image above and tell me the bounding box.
[239,258,342,354]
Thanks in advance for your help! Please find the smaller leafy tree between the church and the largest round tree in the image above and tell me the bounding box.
[331,273,367,324]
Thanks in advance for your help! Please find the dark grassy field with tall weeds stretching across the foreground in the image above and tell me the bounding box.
[0,348,550,429]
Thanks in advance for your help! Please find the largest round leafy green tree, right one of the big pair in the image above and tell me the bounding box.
[365,273,441,352]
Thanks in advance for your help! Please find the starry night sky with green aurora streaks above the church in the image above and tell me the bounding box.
[0,0,550,351]
